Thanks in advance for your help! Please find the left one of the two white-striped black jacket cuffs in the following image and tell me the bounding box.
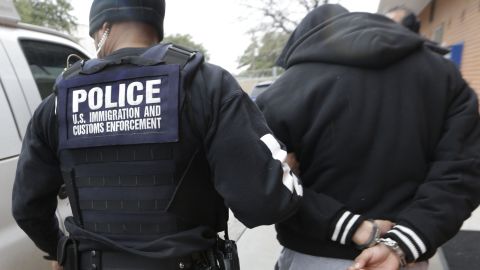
[331,211,365,245]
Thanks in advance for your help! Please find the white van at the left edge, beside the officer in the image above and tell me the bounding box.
[0,0,89,270]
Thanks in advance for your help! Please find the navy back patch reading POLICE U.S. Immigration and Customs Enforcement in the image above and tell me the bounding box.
[57,65,180,149]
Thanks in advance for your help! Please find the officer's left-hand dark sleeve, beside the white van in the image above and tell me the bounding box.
[12,97,62,259]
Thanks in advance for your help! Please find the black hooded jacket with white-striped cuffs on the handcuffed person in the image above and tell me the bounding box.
[257,5,480,262]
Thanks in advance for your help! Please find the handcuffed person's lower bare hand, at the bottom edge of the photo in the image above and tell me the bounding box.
[348,244,400,270]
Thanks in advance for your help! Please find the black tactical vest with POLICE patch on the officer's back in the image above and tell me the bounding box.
[57,45,227,257]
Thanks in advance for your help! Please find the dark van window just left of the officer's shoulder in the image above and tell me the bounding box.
[20,40,87,99]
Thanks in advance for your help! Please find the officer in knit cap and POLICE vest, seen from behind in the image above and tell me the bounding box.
[13,0,303,270]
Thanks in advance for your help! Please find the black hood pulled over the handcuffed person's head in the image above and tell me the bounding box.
[277,5,424,69]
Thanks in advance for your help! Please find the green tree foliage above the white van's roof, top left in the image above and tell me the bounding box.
[13,0,77,34]
